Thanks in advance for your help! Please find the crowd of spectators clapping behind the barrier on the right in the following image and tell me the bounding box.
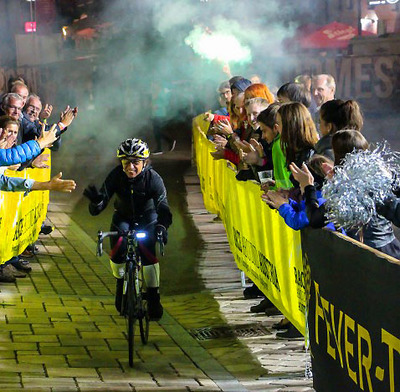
[204,74,400,338]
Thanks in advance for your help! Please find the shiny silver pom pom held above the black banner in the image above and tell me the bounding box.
[322,142,400,230]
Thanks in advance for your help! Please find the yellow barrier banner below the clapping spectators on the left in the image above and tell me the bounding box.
[0,150,50,264]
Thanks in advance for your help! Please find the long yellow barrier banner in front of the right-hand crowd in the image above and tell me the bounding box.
[193,115,306,334]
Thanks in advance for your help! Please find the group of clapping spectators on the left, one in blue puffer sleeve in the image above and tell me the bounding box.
[0,77,78,283]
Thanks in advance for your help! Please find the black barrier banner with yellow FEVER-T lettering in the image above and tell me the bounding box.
[302,229,400,392]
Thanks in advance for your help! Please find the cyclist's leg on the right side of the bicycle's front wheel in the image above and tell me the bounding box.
[139,225,163,321]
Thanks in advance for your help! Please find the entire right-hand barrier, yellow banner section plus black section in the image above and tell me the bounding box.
[193,115,400,392]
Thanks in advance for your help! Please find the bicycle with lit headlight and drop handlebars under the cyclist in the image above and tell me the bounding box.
[96,230,164,367]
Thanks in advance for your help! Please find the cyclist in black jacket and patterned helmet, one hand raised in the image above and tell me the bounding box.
[83,139,172,320]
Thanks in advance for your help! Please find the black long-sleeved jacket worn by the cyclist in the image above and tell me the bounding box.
[89,165,172,228]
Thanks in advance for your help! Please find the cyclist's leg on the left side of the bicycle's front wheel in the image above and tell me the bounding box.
[110,214,129,312]
